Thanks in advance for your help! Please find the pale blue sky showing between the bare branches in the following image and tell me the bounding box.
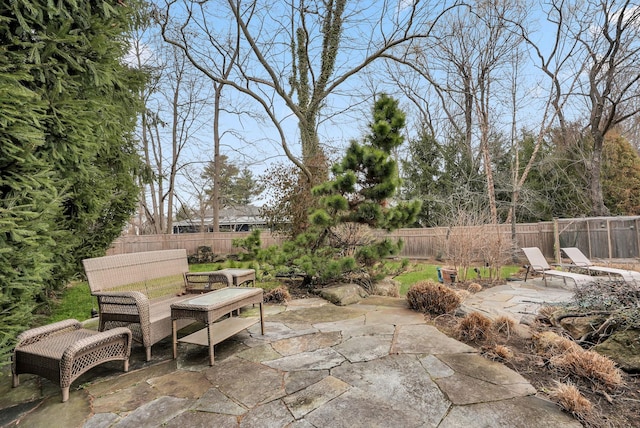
[142,0,640,214]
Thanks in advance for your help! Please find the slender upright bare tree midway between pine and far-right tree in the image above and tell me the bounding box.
[389,0,524,223]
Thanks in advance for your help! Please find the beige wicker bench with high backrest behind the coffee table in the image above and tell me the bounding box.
[82,249,255,361]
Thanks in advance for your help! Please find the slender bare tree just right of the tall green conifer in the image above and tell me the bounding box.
[133,23,208,233]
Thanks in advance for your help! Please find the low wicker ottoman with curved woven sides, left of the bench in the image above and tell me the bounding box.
[11,320,131,402]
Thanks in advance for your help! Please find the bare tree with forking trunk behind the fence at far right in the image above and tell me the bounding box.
[521,0,640,215]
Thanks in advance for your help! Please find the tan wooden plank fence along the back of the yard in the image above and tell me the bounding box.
[107,216,640,259]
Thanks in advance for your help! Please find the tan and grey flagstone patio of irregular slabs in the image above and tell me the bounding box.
[0,279,581,428]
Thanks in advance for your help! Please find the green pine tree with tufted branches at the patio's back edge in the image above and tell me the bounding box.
[263,95,421,285]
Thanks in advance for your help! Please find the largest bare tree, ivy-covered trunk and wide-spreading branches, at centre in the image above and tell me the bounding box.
[159,0,462,188]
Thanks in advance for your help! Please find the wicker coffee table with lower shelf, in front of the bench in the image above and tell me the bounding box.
[171,287,264,365]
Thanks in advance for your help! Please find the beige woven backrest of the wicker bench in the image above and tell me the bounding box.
[82,249,189,298]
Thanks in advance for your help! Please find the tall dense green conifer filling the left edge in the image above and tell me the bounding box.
[0,0,142,365]
